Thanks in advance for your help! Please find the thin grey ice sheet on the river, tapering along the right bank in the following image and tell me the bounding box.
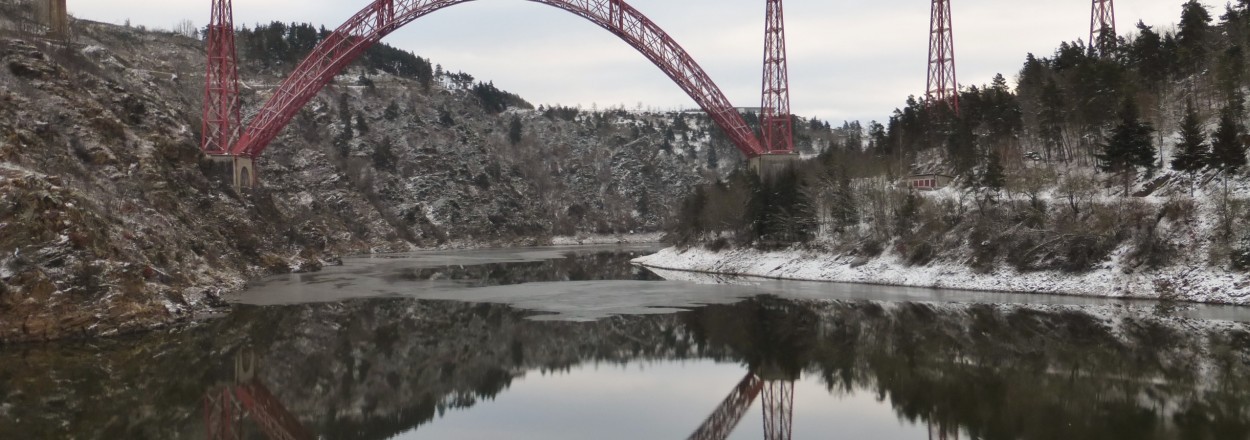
[236,246,1250,321]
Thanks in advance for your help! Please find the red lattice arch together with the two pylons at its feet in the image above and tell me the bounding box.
[201,0,794,186]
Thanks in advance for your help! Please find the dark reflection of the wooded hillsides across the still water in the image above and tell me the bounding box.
[0,298,1250,439]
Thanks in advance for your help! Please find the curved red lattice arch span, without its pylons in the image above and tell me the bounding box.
[229,0,771,158]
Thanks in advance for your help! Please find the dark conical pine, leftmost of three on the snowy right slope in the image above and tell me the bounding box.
[1095,99,1156,194]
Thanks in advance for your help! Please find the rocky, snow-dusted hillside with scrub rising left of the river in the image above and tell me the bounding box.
[0,15,735,341]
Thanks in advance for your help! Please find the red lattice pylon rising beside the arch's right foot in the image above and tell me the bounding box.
[760,0,794,154]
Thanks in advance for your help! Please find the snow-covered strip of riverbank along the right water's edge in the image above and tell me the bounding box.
[634,248,1250,305]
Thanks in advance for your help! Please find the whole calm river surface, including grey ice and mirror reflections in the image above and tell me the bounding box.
[0,246,1250,439]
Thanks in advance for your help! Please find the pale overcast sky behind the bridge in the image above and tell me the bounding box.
[69,0,1190,124]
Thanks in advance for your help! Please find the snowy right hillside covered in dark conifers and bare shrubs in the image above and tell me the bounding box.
[670,1,1250,301]
